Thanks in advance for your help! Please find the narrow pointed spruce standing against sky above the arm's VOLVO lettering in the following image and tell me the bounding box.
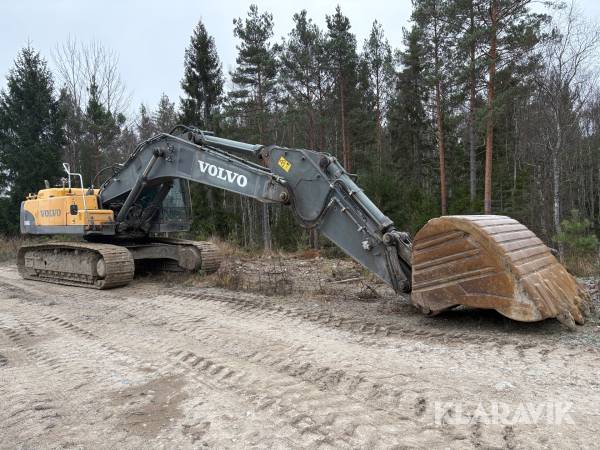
[180,21,223,129]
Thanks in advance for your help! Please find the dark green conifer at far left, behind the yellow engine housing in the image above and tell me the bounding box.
[0,46,63,231]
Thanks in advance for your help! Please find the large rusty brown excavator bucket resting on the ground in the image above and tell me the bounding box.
[411,215,591,328]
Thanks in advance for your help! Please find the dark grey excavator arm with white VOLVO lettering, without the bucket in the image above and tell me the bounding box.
[99,127,411,292]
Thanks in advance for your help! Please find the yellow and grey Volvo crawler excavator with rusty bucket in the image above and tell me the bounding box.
[17,125,591,328]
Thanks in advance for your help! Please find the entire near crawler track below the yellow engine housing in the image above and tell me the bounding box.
[17,242,135,289]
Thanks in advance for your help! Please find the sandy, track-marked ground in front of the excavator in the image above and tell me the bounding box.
[0,253,600,449]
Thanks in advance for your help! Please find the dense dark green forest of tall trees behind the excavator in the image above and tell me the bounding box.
[0,0,600,268]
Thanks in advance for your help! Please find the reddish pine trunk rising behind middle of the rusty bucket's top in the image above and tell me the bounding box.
[483,0,498,214]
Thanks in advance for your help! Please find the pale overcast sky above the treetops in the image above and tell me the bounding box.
[0,0,600,116]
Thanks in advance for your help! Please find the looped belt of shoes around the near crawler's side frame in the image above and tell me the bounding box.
[17,242,135,289]
